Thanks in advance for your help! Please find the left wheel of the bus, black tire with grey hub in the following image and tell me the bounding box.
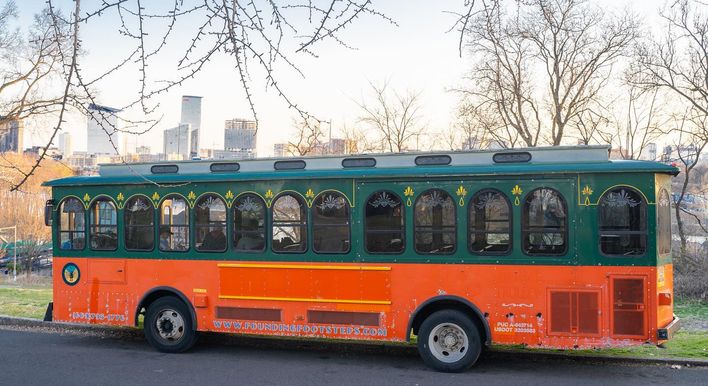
[143,296,197,353]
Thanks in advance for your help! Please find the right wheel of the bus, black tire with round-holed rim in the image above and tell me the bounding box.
[418,310,482,373]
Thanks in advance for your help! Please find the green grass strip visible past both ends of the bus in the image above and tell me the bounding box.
[0,286,708,360]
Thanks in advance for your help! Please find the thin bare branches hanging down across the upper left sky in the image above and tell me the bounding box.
[1,0,395,189]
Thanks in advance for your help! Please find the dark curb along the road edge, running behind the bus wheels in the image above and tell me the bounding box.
[0,315,708,367]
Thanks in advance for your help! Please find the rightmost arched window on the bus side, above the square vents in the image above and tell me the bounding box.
[598,187,647,256]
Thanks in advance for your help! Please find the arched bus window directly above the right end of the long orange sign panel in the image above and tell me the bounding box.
[364,190,406,253]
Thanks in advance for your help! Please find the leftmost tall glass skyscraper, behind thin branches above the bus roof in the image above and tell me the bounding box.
[86,103,120,154]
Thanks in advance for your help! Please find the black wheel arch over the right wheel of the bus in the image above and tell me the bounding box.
[406,295,492,346]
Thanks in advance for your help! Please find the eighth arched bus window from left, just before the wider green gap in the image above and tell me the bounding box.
[312,192,350,253]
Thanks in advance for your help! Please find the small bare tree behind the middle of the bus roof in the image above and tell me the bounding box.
[359,82,424,153]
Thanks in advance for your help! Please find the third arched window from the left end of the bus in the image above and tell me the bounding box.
[123,196,155,251]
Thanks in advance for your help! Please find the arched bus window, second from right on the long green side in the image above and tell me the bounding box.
[521,188,568,256]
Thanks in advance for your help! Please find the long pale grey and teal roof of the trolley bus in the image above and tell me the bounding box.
[43,146,678,186]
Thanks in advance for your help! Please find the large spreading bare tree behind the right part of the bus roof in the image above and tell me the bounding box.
[458,0,638,146]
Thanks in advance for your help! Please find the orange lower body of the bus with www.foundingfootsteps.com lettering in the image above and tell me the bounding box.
[53,257,673,348]
